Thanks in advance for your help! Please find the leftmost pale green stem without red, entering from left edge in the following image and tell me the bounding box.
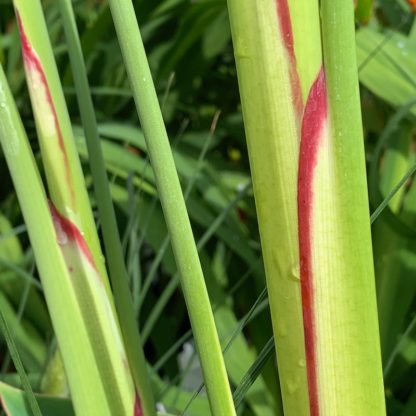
[0,67,111,415]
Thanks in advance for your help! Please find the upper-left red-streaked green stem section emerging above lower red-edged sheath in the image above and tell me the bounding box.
[13,0,111,297]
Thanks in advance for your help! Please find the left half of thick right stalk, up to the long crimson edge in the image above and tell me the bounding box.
[224,0,322,415]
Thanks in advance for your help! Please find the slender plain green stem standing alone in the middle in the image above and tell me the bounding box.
[110,0,235,416]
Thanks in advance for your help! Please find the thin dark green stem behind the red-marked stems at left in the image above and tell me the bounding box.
[59,0,156,416]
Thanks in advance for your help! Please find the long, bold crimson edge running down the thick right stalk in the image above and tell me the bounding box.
[298,69,328,416]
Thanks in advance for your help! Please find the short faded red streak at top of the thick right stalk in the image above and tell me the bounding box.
[275,0,303,117]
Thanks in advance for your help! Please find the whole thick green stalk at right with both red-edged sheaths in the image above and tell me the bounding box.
[228,0,384,416]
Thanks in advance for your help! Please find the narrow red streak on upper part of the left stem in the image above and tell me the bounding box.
[16,10,75,206]
